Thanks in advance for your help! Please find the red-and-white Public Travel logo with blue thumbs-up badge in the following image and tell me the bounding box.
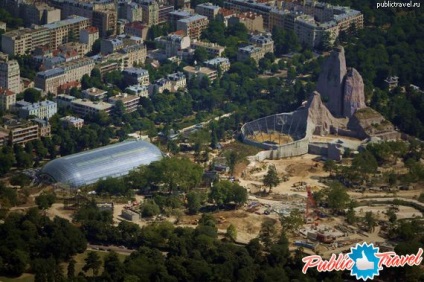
[302,243,423,281]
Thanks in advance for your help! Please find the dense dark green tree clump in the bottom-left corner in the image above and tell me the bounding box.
[0,208,87,276]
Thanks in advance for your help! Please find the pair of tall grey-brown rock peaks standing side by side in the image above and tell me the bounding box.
[317,47,366,118]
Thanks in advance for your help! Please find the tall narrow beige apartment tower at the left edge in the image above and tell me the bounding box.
[0,53,21,94]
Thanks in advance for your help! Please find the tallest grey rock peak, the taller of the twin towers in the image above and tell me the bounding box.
[317,46,347,117]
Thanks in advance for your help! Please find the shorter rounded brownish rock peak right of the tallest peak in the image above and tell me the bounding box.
[343,68,366,118]
